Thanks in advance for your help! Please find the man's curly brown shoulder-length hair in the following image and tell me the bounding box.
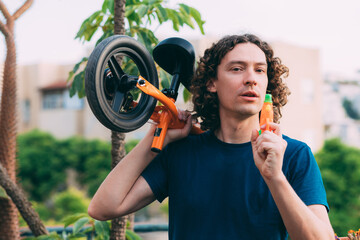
[190,34,290,130]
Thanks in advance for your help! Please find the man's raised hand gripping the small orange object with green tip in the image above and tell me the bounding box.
[251,123,287,180]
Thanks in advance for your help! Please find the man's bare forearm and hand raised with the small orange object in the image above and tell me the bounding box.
[251,123,334,240]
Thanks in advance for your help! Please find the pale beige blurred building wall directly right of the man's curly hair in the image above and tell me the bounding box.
[271,42,324,151]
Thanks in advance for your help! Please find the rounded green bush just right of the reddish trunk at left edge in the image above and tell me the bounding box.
[17,130,66,201]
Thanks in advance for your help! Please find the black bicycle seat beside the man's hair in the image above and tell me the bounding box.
[153,37,195,90]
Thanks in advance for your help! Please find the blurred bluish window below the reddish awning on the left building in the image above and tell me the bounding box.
[42,89,84,110]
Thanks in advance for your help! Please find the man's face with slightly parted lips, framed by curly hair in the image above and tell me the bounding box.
[208,43,268,118]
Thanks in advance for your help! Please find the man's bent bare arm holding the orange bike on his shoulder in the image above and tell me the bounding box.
[88,112,191,220]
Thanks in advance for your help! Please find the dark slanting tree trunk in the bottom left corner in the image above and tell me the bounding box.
[0,164,48,235]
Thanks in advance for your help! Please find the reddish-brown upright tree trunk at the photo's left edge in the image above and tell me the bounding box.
[0,21,20,239]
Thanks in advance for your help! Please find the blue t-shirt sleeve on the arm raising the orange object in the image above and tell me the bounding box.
[289,144,329,211]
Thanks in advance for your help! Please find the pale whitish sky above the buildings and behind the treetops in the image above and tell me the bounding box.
[0,0,360,74]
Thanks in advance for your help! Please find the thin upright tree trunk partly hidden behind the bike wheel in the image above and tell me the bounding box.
[110,0,131,240]
